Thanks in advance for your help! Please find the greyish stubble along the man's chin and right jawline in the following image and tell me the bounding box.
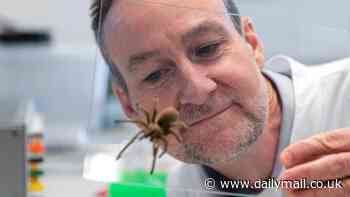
[182,84,268,166]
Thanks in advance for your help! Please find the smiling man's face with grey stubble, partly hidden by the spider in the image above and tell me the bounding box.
[104,0,267,165]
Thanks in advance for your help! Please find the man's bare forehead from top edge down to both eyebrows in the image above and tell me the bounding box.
[105,0,230,68]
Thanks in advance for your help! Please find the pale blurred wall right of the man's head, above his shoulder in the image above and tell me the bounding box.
[236,0,350,64]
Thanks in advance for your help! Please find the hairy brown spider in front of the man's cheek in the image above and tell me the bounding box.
[115,102,187,174]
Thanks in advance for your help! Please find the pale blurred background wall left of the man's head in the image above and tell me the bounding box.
[0,0,96,144]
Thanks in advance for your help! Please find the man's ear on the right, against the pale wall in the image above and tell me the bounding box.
[241,16,265,68]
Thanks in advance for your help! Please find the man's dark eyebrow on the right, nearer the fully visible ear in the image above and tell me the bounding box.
[182,21,228,44]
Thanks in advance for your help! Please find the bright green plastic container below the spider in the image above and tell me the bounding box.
[108,171,167,197]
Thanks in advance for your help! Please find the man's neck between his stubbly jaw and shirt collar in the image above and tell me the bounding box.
[210,77,282,181]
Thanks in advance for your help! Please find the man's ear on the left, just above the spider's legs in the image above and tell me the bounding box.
[112,82,137,118]
